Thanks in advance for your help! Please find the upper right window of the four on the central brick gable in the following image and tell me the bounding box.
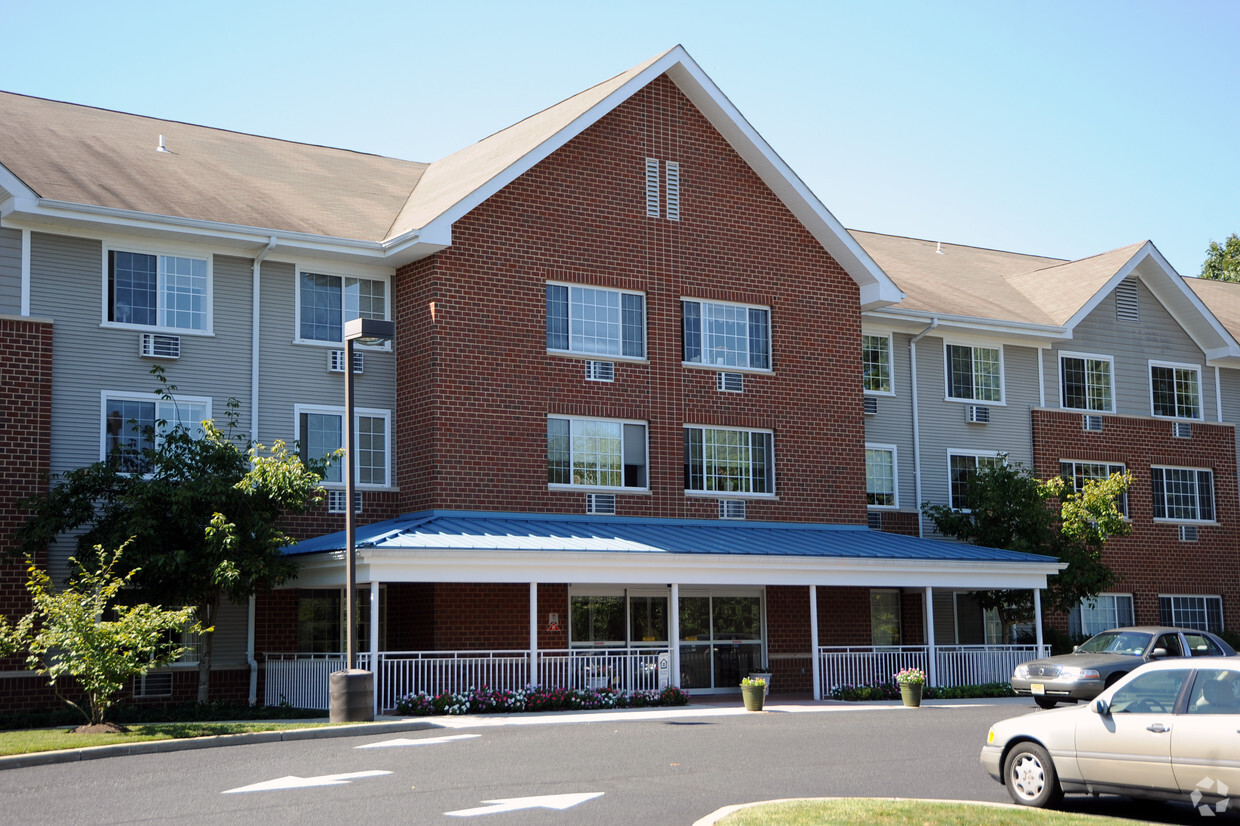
[681,301,771,370]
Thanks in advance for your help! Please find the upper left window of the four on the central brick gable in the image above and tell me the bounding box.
[547,284,646,358]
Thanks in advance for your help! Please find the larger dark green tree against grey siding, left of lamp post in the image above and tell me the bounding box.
[17,366,325,702]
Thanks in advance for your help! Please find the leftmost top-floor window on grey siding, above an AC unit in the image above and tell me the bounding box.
[107,249,211,332]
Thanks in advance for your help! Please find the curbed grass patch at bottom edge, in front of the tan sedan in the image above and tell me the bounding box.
[719,797,1133,826]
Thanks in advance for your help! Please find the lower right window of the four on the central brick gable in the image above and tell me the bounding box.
[684,427,775,494]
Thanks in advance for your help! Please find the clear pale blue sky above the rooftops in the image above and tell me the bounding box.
[0,0,1240,275]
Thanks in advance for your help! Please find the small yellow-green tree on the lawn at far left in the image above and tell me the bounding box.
[0,547,202,726]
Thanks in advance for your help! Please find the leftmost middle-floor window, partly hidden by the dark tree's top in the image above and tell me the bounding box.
[99,391,211,474]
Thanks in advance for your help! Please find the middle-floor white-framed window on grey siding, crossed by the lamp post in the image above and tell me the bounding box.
[293,404,392,487]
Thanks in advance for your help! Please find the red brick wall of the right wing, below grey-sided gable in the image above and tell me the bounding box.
[1033,411,1240,629]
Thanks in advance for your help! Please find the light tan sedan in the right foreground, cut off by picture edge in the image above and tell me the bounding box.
[981,657,1240,814]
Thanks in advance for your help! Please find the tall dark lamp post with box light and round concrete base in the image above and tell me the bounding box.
[329,319,396,723]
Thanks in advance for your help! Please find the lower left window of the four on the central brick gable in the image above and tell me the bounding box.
[547,415,649,490]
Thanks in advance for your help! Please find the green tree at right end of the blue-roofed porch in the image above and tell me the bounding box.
[921,461,1132,635]
